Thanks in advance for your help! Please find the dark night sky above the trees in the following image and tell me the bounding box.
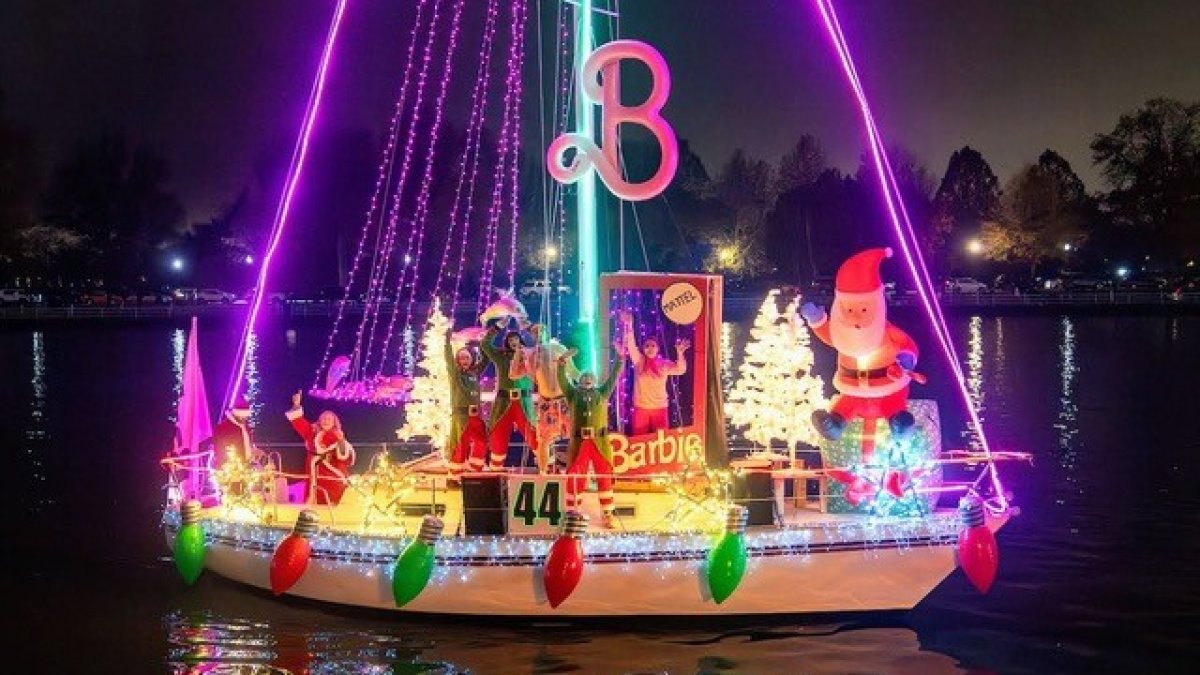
[0,0,1200,220]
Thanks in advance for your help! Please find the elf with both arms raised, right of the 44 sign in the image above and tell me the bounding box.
[558,345,625,527]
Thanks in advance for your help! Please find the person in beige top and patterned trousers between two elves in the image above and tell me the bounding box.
[509,323,580,473]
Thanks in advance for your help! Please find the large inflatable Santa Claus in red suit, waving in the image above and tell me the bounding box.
[800,249,922,441]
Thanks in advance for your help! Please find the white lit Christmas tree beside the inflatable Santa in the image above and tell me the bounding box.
[725,289,828,453]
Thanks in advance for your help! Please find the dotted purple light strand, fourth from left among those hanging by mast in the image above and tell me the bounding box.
[431,0,499,317]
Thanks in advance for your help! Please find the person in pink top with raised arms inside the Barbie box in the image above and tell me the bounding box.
[620,312,691,436]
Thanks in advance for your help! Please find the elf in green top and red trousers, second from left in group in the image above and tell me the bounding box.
[480,323,538,470]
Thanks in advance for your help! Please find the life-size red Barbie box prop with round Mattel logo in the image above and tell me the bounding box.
[600,271,728,476]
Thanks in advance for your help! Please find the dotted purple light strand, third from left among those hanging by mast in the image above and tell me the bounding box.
[379,0,464,371]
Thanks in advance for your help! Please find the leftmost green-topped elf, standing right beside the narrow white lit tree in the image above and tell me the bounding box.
[445,336,487,477]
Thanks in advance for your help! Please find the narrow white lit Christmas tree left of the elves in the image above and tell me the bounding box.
[396,299,450,452]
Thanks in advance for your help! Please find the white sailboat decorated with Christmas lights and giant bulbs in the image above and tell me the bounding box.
[162,0,1028,617]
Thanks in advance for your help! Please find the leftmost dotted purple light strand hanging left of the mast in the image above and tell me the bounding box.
[312,0,428,390]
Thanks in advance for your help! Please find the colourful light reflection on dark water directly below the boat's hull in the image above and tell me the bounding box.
[163,611,965,675]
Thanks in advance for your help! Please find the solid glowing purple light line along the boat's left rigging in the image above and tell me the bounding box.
[226,0,348,407]
